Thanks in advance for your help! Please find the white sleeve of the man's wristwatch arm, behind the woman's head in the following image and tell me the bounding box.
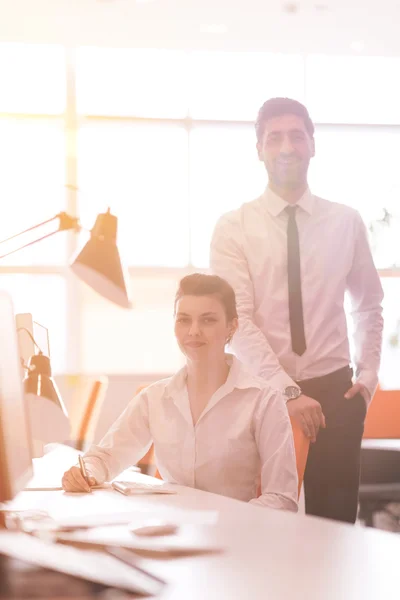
[210,213,297,392]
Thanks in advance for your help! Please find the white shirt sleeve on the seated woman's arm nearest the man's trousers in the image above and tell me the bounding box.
[250,391,298,512]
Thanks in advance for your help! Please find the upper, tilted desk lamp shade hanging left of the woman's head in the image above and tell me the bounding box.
[71,209,132,308]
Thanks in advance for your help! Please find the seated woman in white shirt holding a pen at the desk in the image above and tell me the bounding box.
[62,273,297,511]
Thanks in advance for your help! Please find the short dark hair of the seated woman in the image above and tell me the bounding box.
[174,273,238,321]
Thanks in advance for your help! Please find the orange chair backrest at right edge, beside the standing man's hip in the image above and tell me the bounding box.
[364,387,400,439]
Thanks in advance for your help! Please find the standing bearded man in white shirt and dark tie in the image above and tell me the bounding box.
[211,98,383,523]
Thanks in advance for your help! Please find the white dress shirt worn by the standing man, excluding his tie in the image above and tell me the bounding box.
[210,188,383,404]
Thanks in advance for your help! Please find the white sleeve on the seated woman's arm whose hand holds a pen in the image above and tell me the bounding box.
[83,390,152,484]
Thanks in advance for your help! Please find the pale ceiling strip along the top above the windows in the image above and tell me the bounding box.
[0,0,400,56]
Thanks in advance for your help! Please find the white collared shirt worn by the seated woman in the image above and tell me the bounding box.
[84,355,298,511]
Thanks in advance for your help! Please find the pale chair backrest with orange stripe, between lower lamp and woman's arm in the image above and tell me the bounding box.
[69,376,108,450]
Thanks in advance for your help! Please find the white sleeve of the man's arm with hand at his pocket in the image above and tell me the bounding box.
[347,212,383,398]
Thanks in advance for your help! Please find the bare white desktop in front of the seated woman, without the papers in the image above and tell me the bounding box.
[3,450,400,600]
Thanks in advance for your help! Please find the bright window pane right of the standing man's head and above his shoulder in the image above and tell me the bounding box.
[310,126,400,268]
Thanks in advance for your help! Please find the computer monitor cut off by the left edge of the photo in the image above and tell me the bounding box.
[0,290,33,502]
